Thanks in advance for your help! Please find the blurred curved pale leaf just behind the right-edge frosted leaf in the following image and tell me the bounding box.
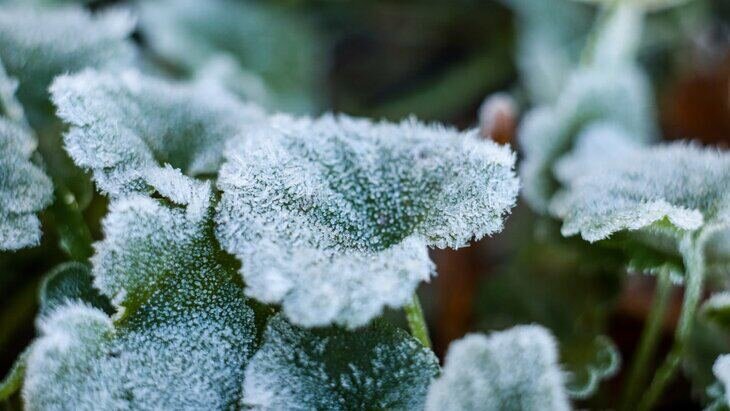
[518,65,653,213]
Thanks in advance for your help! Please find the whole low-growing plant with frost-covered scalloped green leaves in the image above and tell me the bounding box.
[0,0,730,411]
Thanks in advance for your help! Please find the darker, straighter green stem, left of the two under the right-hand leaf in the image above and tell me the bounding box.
[619,268,672,410]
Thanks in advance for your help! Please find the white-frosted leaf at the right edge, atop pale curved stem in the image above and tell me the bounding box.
[551,128,730,242]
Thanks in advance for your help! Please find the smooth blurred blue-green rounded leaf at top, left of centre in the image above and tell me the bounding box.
[139,0,320,111]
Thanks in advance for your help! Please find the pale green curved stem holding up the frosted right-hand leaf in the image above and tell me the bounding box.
[638,235,705,411]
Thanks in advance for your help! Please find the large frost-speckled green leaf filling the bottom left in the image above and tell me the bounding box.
[23,170,256,410]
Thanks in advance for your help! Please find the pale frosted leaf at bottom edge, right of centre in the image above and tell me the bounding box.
[426,325,570,411]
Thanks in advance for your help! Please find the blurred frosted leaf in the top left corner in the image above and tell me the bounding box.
[0,5,135,117]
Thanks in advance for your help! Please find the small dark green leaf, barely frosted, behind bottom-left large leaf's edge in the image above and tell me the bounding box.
[40,262,113,316]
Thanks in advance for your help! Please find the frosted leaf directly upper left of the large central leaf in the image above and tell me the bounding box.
[51,70,264,196]
